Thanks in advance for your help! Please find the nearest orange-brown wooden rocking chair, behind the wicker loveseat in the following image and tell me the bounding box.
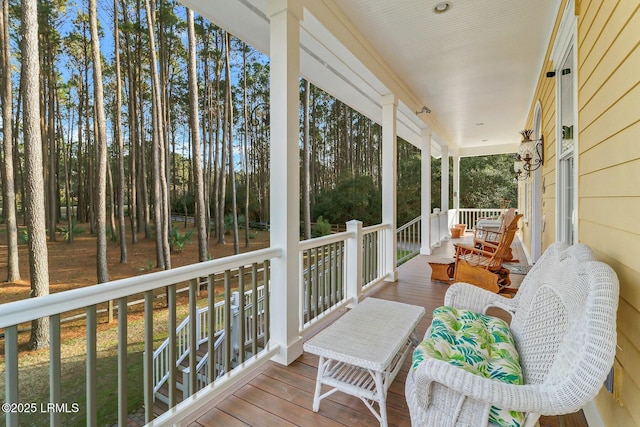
[454,214,522,293]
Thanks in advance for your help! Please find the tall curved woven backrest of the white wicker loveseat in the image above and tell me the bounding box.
[511,243,618,406]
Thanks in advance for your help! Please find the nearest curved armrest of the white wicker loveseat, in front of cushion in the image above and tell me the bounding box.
[413,358,564,415]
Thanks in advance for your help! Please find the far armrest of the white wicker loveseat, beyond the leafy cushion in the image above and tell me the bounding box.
[444,282,516,314]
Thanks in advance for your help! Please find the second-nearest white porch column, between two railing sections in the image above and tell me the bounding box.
[382,94,398,282]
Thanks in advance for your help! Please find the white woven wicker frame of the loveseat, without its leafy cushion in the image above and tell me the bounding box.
[405,243,619,427]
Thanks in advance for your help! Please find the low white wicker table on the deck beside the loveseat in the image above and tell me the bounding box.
[304,298,425,427]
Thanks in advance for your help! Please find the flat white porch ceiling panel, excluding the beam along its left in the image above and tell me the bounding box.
[336,0,560,152]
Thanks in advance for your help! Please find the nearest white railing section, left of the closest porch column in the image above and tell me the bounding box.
[0,249,282,426]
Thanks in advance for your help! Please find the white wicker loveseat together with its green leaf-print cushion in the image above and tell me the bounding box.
[405,242,619,427]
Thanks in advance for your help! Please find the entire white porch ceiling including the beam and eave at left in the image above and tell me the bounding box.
[182,0,561,156]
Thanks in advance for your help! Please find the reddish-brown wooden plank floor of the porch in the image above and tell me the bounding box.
[183,239,587,427]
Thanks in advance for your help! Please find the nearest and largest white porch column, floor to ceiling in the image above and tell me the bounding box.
[267,0,302,365]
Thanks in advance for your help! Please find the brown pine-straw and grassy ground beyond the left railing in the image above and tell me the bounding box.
[0,224,269,426]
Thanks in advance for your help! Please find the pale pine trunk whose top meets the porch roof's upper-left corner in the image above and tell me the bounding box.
[187,8,209,262]
